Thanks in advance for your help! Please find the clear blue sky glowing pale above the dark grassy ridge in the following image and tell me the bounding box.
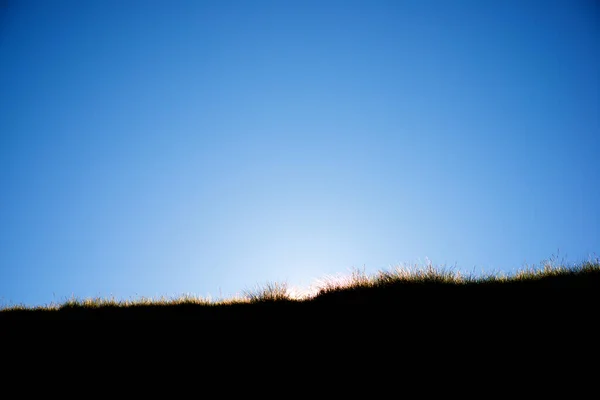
[0,0,600,305]
